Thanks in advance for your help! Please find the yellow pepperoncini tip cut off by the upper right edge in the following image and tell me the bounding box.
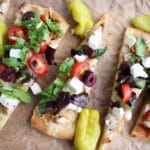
[132,15,150,32]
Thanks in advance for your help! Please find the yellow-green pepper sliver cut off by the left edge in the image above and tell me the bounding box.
[0,20,8,58]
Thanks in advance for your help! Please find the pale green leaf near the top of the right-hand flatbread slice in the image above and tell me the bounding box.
[135,36,147,57]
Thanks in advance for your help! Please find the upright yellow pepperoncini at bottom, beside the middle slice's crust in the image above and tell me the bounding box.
[74,108,100,150]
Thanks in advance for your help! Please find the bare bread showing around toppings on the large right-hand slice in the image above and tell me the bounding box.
[99,27,150,150]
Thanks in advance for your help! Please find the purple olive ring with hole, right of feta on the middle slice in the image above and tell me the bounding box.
[83,70,97,87]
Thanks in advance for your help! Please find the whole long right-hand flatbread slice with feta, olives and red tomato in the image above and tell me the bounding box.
[99,27,150,149]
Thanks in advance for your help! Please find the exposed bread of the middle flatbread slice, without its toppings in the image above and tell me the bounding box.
[31,14,107,140]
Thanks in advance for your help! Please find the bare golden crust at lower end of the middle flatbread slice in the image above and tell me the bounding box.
[31,107,78,140]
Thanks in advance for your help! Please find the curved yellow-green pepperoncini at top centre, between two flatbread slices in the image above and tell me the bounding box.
[69,0,93,37]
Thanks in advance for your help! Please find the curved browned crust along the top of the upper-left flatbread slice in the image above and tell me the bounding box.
[15,2,69,49]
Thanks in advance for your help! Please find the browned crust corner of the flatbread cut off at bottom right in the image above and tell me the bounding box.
[131,102,150,142]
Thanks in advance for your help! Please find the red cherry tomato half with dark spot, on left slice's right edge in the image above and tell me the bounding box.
[29,54,48,76]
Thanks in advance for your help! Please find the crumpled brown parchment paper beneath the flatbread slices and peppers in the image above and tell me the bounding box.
[0,0,150,150]
